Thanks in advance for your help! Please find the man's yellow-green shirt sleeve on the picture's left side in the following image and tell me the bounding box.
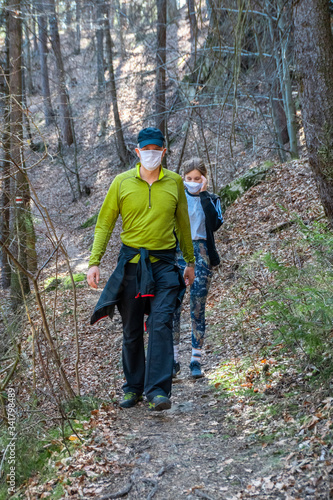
[89,177,119,267]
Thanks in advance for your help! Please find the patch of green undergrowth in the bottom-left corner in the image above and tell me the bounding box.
[0,397,101,500]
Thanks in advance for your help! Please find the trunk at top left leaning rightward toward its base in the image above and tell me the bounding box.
[44,0,74,146]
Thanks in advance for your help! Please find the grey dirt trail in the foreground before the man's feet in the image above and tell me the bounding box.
[78,326,282,499]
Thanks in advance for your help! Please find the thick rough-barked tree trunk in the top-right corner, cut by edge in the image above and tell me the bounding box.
[294,0,333,226]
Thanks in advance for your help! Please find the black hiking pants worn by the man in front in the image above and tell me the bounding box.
[118,260,179,401]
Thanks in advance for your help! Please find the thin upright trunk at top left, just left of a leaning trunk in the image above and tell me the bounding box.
[37,2,54,126]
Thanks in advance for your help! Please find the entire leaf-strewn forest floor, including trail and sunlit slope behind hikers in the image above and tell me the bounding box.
[0,8,333,500]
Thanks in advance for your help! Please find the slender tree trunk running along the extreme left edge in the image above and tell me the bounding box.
[0,23,11,288]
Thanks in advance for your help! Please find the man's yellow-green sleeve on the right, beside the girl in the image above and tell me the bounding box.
[175,177,195,262]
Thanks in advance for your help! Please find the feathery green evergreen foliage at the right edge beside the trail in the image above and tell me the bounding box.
[263,221,333,375]
